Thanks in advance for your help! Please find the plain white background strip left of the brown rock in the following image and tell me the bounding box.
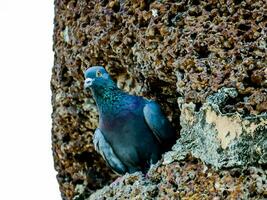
[0,0,61,200]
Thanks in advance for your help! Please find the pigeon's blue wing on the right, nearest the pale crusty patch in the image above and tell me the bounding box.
[143,101,176,146]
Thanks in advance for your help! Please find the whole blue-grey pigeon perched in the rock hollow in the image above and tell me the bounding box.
[84,66,176,175]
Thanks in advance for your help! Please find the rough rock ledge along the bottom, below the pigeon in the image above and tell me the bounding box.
[87,157,267,200]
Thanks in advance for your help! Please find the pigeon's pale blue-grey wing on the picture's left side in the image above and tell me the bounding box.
[93,128,127,174]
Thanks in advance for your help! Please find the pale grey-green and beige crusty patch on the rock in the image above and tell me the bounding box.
[164,88,267,169]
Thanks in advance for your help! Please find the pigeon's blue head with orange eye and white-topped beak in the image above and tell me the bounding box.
[84,66,116,91]
